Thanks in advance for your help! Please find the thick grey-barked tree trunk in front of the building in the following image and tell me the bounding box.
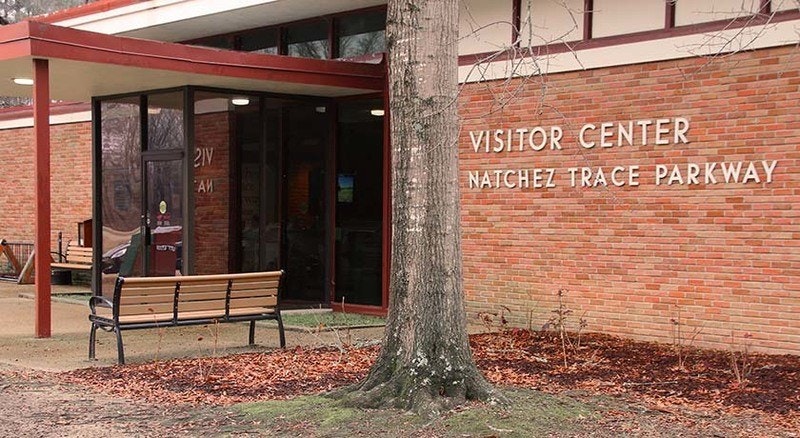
[338,0,500,415]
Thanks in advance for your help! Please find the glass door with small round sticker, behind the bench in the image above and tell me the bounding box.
[142,158,183,276]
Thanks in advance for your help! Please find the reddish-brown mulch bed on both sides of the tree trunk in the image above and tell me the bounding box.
[59,329,800,425]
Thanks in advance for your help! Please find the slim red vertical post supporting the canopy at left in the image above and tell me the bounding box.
[33,59,51,338]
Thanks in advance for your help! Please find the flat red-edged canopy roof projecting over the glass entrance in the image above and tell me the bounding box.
[0,21,385,101]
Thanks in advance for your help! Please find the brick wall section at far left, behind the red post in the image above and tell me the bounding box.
[0,123,92,249]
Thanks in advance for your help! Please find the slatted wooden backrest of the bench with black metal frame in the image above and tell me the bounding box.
[114,271,283,319]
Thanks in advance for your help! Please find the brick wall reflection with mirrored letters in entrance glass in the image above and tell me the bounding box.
[193,112,232,274]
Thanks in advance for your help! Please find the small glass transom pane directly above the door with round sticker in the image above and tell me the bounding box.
[147,91,183,151]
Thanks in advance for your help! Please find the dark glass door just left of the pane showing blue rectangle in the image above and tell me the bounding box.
[282,104,331,302]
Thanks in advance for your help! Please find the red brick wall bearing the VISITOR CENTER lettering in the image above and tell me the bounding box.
[460,44,800,354]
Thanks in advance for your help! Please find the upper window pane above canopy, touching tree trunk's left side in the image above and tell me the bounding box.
[336,11,386,58]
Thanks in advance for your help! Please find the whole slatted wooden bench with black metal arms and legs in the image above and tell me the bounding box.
[89,271,286,364]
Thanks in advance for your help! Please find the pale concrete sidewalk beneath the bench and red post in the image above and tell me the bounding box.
[0,282,383,371]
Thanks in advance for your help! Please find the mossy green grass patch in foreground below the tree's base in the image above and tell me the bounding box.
[236,389,602,437]
